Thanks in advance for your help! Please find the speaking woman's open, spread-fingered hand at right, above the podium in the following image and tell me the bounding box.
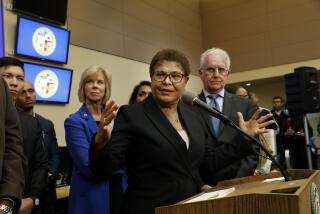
[237,109,274,137]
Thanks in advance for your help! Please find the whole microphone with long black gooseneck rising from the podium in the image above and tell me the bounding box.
[181,91,292,181]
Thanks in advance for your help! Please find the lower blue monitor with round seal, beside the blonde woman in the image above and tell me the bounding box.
[24,62,73,104]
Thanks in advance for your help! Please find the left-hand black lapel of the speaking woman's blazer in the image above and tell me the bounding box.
[143,97,194,177]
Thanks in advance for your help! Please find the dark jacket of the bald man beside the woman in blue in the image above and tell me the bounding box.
[34,114,60,202]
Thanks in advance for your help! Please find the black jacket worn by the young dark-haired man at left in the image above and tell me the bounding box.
[17,108,48,203]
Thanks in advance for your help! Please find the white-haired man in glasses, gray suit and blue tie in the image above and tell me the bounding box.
[198,48,259,185]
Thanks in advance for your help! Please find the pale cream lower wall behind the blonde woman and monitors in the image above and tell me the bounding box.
[4,0,201,146]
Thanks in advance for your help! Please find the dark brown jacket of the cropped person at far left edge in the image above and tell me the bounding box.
[0,78,24,210]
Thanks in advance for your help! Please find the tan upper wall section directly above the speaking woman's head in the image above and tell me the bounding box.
[67,0,202,73]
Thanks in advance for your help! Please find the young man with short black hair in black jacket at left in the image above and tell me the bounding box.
[0,57,48,213]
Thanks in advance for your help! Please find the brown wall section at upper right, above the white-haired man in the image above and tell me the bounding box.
[200,0,320,75]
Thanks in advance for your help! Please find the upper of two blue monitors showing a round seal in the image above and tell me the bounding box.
[15,16,70,64]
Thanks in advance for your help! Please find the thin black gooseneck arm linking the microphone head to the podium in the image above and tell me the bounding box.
[206,109,293,181]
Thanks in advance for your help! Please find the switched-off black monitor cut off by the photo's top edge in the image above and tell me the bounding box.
[12,0,68,25]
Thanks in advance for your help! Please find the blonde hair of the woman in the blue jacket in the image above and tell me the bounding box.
[78,65,111,103]
